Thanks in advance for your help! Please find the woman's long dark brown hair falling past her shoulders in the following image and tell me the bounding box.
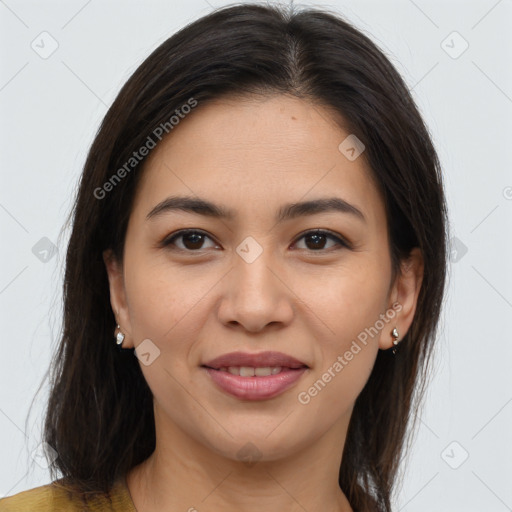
[33,3,447,512]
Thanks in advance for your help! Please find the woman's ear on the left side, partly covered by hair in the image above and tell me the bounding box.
[103,249,134,348]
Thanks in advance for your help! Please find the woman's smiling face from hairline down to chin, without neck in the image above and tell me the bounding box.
[106,96,420,460]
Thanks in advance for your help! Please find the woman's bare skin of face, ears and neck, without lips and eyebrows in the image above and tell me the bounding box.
[104,95,423,512]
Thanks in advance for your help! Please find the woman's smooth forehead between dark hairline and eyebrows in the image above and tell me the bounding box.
[135,95,384,226]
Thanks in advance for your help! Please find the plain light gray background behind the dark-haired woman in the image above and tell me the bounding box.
[0,0,512,512]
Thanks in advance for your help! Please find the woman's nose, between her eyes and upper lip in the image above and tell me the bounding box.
[218,249,295,333]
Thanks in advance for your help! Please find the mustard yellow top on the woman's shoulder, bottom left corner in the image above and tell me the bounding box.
[0,478,137,512]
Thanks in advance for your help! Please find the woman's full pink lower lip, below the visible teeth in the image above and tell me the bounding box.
[203,367,307,400]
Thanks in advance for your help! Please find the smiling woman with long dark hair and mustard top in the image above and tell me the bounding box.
[0,4,447,512]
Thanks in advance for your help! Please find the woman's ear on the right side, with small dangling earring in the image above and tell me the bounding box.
[379,247,423,350]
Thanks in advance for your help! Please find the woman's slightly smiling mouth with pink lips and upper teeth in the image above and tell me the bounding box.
[201,352,309,400]
